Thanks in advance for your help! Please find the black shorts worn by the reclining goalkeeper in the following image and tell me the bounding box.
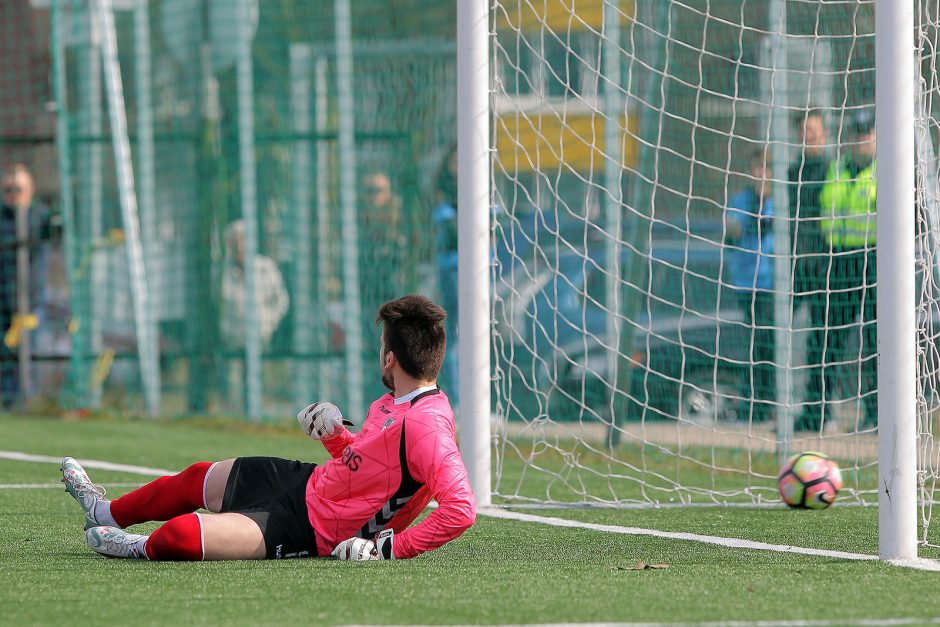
[221,457,317,559]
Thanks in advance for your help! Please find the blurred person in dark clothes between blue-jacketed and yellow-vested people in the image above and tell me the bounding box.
[788,109,829,432]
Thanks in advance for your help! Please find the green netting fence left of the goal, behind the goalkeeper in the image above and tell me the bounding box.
[43,0,456,418]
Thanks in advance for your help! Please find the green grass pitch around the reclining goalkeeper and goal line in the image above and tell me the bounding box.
[0,416,940,625]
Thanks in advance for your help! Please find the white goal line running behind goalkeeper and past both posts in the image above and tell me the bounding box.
[0,451,940,576]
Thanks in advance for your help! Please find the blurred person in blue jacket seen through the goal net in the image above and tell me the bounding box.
[725,150,776,422]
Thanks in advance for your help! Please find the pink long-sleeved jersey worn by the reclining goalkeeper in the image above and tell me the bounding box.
[307,388,476,558]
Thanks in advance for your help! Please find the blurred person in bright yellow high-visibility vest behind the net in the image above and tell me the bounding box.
[797,109,878,430]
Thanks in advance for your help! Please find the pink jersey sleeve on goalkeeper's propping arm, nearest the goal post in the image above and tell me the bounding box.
[394,411,476,558]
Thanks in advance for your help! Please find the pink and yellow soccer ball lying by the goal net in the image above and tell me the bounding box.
[777,451,842,509]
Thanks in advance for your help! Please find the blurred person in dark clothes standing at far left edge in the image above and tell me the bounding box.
[0,163,51,408]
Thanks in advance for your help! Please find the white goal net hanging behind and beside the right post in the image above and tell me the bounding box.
[491,0,940,542]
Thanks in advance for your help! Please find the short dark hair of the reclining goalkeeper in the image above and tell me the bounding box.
[375,294,447,381]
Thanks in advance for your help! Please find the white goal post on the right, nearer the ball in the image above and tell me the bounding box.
[875,2,926,560]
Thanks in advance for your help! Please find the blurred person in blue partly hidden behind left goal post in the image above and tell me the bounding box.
[431,146,460,409]
